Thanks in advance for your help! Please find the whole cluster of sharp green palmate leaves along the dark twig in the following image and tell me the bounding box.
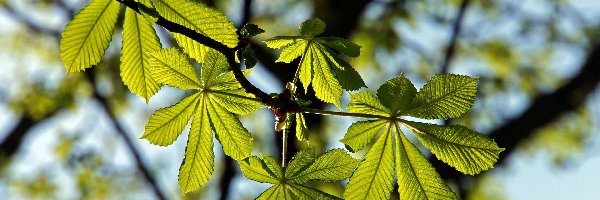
[60,0,503,199]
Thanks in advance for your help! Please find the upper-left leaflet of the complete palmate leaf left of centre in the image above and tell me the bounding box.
[150,48,202,89]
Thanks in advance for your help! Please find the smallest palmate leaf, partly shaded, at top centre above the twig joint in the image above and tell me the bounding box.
[265,19,365,108]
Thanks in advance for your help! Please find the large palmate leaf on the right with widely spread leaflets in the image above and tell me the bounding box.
[340,74,503,199]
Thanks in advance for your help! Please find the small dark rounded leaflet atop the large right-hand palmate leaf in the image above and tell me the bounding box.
[377,74,417,113]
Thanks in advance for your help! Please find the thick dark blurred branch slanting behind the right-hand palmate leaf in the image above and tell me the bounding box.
[429,41,600,195]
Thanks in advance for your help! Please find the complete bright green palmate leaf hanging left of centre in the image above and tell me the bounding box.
[142,48,262,194]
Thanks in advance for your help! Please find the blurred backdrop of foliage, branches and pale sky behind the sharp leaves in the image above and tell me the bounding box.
[0,0,600,200]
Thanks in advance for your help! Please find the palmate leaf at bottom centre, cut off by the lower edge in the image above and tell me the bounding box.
[239,149,359,199]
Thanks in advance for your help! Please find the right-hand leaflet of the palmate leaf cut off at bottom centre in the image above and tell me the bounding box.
[289,149,360,184]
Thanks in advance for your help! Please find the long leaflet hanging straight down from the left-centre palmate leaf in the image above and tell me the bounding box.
[179,97,215,195]
